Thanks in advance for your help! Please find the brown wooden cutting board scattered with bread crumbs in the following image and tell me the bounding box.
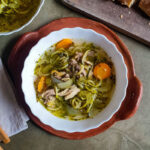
[62,0,150,46]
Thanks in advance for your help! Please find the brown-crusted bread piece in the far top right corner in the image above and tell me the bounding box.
[139,0,150,17]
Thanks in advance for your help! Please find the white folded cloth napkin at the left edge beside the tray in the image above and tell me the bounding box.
[0,59,29,136]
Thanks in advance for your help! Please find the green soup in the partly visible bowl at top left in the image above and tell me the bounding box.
[0,0,41,32]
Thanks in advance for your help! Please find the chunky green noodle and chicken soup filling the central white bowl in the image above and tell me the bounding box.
[34,42,116,121]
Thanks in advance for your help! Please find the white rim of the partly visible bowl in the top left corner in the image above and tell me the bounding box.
[0,0,45,36]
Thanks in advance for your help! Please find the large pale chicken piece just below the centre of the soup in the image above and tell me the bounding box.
[58,85,80,100]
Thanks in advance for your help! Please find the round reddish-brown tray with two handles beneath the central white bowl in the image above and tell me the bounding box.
[7,18,142,139]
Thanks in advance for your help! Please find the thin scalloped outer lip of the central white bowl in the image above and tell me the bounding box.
[21,27,128,133]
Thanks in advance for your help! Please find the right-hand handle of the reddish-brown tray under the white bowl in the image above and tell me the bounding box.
[116,76,143,120]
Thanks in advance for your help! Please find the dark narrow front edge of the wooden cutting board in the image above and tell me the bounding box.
[61,0,150,46]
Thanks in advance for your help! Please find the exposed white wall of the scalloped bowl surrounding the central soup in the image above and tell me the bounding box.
[21,27,128,133]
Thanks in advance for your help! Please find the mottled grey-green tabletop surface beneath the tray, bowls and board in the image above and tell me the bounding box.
[0,0,150,150]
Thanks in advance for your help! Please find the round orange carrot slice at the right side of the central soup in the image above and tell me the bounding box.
[93,63,111,80]
